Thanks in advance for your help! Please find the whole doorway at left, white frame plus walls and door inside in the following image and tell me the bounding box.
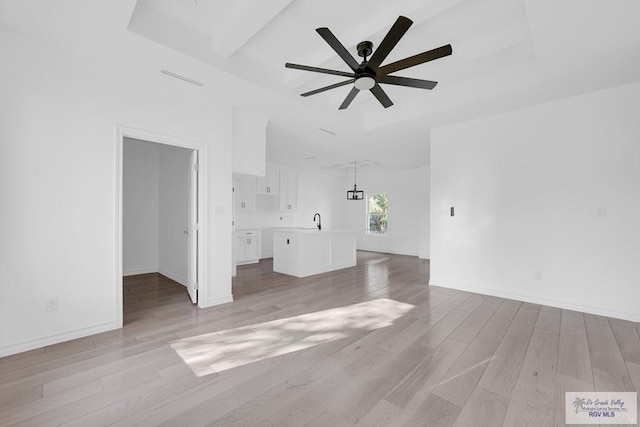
[116,127,206,327]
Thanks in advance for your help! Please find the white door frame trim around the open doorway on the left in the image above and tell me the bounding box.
[115,125,208,328]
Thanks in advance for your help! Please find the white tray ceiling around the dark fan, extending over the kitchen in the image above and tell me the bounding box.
[0,0,640,173]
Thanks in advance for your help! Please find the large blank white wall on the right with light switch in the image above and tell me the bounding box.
[430,83,640,321]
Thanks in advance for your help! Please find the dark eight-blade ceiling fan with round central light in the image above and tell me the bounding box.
[285,16,452,110]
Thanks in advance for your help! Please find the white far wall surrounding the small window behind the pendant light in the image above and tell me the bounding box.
[340,168,429,256]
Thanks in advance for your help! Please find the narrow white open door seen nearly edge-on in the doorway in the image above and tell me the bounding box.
[187,150,199,304]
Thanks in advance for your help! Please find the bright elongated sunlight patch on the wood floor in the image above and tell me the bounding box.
[171,298,414,376]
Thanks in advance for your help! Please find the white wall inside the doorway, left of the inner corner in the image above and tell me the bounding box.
[122,138,160,276]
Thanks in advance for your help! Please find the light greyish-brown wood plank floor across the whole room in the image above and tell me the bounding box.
[0,252,640,427]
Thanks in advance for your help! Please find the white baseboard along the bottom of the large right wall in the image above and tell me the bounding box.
[429,280,640,322]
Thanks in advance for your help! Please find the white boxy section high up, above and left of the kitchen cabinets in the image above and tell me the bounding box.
[231,107,267,176]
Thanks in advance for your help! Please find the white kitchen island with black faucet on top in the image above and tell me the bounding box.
[273,228,356,277]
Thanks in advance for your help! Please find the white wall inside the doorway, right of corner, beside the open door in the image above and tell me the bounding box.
[158,145,191,286]
